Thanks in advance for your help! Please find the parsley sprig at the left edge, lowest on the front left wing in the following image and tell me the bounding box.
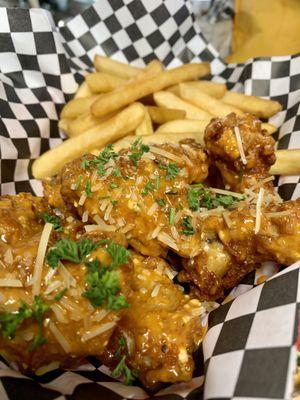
[0,296,50,351]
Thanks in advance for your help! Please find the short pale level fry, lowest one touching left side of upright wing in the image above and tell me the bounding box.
[155,119,210,135]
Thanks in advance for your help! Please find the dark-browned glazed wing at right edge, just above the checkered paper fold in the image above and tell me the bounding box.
[181,199,300,300]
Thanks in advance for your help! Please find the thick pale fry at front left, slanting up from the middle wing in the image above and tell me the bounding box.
[32,104,144,179]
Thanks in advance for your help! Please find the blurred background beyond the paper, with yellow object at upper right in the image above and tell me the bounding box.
[0,0,300,62]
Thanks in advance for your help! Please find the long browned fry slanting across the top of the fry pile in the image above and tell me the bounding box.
[91,63,210,117]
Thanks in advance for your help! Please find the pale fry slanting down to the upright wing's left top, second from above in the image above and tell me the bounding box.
[153,91,212,120]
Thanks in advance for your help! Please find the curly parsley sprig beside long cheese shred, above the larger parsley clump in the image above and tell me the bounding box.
[46,238,99,268]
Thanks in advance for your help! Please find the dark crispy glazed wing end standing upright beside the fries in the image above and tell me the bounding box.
[204,113,276,193]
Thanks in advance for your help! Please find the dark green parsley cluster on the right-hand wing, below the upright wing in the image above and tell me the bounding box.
[187,186,239,211]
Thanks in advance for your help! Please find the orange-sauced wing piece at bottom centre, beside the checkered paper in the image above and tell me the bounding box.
[104,254,204,387]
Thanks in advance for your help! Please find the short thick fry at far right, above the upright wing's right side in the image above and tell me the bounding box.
[222,91,282,119]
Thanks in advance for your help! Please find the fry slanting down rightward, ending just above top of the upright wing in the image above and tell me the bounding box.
[179,83,243,117]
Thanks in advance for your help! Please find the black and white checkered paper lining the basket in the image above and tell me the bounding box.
[0,0,300,400]
